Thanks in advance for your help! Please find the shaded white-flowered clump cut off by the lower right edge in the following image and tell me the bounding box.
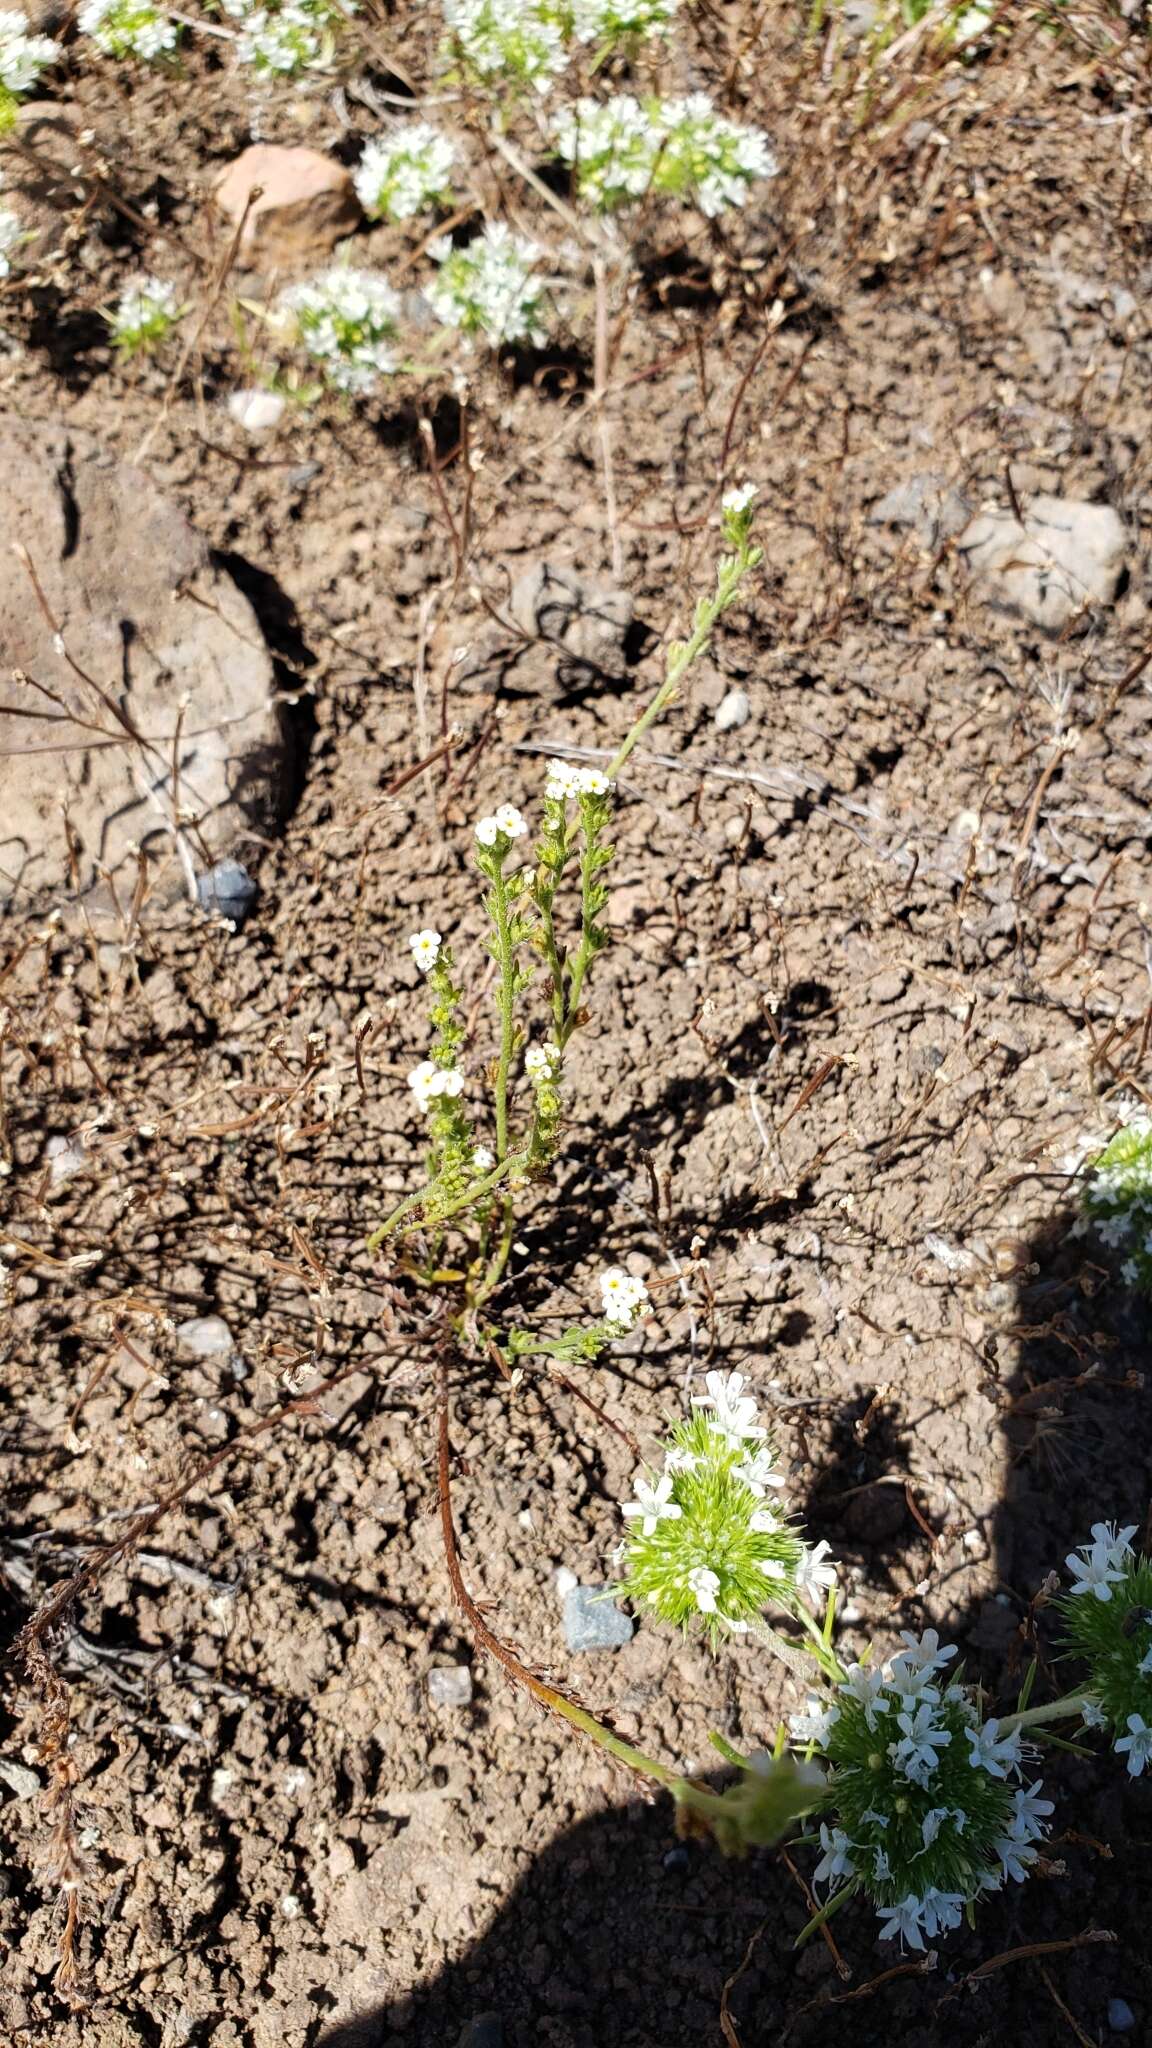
[1058,1522,1152,1778]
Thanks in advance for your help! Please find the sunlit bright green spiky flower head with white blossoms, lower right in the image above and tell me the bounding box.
[621,1372,834,1647]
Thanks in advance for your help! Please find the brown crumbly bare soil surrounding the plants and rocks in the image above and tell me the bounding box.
[0,4,1152,2048]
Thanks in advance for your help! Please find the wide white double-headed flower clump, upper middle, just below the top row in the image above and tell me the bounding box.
[551,92,779,219]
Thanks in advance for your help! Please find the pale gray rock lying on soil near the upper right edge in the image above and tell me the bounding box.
[959,498,1127,633]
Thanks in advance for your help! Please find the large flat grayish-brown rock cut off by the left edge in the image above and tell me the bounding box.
[0,416,283,905]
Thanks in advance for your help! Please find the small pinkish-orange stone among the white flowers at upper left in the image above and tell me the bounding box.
[213,141,361,274]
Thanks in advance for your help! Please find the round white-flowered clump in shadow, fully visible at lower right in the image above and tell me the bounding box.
[793,1628,1052,1950]
